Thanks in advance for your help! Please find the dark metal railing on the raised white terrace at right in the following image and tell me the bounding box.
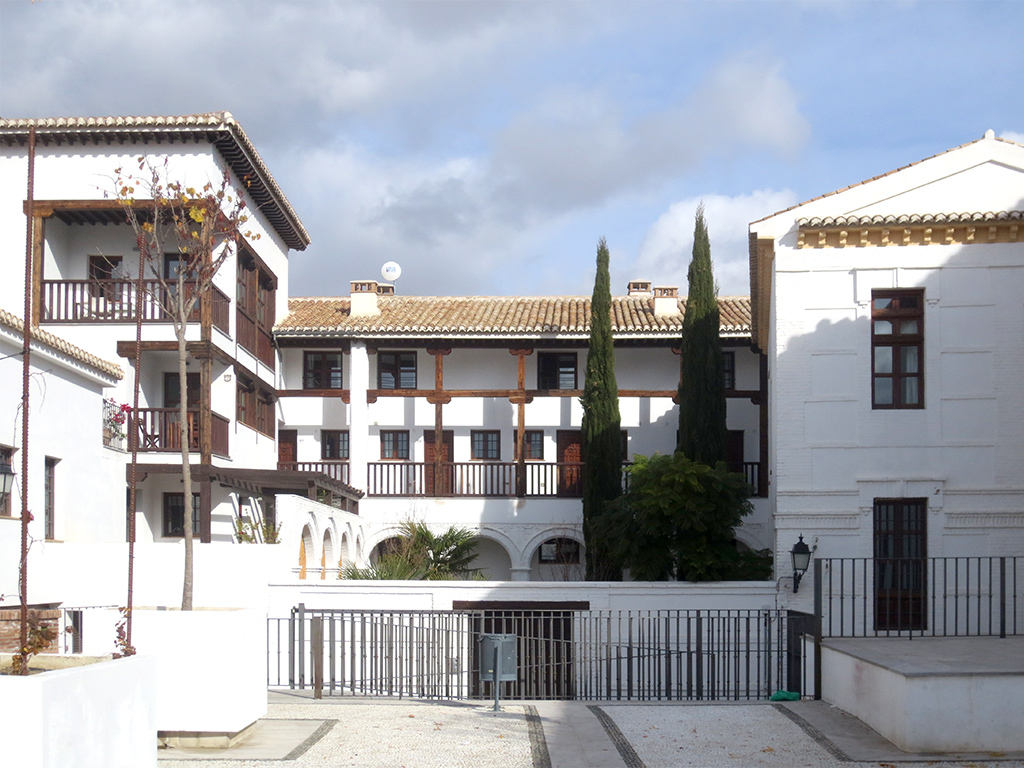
[814,557,1024,638]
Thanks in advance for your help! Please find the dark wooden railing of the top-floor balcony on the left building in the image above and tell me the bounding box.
[40,280,230,333]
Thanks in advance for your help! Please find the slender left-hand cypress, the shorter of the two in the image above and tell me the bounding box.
[581,238,623,581]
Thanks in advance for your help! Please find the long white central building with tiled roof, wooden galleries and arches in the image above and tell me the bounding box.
[274,281,771,581]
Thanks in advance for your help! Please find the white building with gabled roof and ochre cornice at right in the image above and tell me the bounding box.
[750,132,1024,628]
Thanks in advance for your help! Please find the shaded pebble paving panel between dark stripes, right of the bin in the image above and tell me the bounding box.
[603,705,1024,768]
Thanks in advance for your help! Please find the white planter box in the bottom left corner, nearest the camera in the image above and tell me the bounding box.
[0,655,157,768]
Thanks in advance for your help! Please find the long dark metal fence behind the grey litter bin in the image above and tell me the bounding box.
[267,605,801,700]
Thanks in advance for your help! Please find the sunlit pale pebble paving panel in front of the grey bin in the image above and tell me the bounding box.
[161,701,534,768]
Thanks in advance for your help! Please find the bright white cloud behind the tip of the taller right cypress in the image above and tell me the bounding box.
[620,189,799,296]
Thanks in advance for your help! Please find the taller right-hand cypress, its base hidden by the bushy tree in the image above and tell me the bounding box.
[676,203,726,466]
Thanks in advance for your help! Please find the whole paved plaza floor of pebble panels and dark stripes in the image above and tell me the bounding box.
[160,691,1024,768]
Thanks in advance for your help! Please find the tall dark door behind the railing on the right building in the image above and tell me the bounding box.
[874,499,928,631]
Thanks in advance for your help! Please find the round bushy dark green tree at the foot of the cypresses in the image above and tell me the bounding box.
[595,452,753,582]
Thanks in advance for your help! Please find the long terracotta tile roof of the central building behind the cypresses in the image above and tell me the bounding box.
[274,296,751,338]
